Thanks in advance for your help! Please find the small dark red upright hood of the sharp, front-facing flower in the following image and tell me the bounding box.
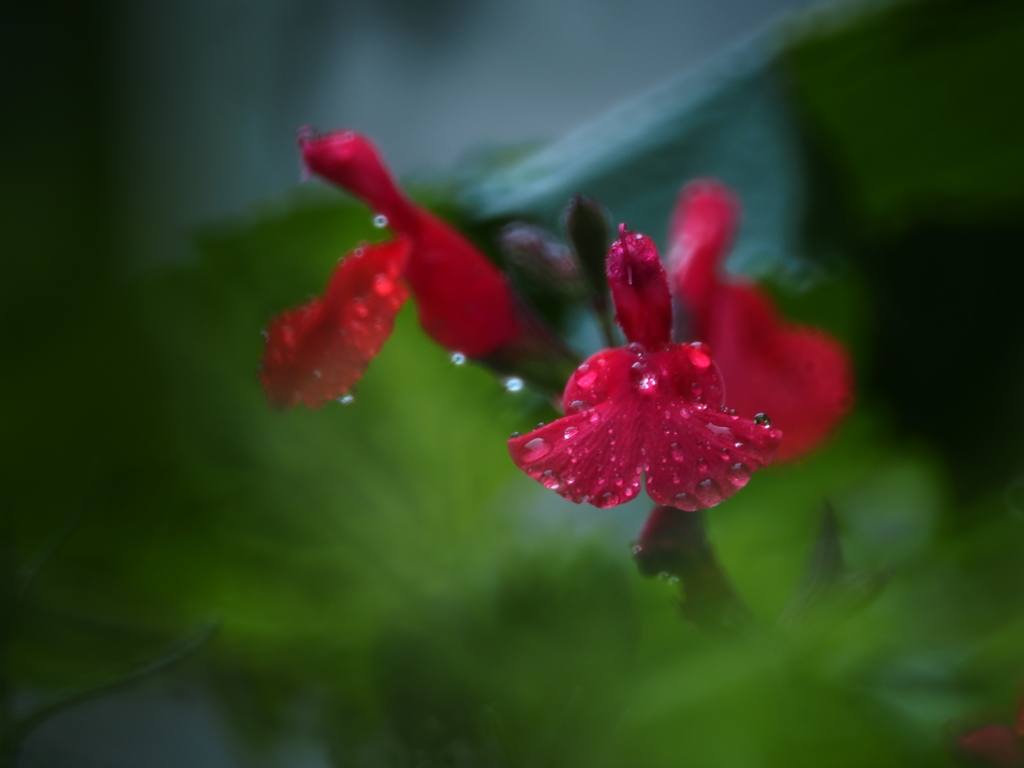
[607,224,672,350]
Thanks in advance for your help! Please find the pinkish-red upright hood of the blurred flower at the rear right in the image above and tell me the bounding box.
[669,179,739,329]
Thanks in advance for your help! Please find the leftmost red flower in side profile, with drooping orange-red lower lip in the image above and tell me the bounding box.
[260,132,534,408]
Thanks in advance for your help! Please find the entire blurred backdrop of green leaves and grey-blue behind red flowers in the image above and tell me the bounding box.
[6,0,1024,766]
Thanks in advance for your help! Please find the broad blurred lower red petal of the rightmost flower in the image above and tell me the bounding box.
[706,284,853,461]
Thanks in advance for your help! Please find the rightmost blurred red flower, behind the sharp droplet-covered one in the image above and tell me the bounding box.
[669,181,853,461]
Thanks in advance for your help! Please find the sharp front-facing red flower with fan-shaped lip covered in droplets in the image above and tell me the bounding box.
[509,228,781,511]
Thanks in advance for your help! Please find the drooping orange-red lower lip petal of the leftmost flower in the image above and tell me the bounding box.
[260,240,409,408]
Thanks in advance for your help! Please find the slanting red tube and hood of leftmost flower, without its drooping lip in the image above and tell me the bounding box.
[299,131,523,357]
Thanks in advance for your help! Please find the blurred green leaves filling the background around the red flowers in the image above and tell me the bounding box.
[2,0,1024,768]
